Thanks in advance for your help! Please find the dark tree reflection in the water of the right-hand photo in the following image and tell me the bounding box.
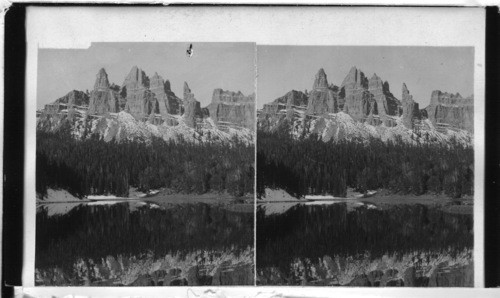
[257,204,473,272]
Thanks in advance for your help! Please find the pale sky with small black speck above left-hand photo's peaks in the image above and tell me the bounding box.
[37,42,255,108]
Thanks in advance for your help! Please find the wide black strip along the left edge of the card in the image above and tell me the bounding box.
[2,4,26,297]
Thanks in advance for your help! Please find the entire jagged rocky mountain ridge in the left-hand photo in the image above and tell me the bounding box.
[37,66,255,139]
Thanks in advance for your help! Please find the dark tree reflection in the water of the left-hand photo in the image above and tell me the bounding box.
[36,204,253,269]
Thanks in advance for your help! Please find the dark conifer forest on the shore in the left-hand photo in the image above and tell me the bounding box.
[36,131,254,197]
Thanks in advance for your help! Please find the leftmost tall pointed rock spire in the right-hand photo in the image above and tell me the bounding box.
[307,68,338,115]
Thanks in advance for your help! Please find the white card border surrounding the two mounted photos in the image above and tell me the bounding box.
[23,7,485,297]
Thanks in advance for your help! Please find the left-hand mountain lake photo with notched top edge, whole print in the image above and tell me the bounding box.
[33,42,256,286]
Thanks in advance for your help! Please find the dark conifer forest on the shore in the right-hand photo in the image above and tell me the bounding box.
[257,131,474,198]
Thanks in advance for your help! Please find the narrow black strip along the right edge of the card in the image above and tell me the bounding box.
[484,6,500,287]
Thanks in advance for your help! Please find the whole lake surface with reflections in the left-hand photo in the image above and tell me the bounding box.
[35,201,254,286]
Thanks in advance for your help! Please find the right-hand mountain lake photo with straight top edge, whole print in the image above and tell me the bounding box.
[256,45,474,287]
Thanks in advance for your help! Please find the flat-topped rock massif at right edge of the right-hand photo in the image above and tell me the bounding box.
[425,90,474,132]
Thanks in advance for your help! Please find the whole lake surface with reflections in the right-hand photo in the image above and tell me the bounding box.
[257,203,473,287]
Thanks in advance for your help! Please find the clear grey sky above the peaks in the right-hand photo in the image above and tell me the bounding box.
[257,45,474,108]
